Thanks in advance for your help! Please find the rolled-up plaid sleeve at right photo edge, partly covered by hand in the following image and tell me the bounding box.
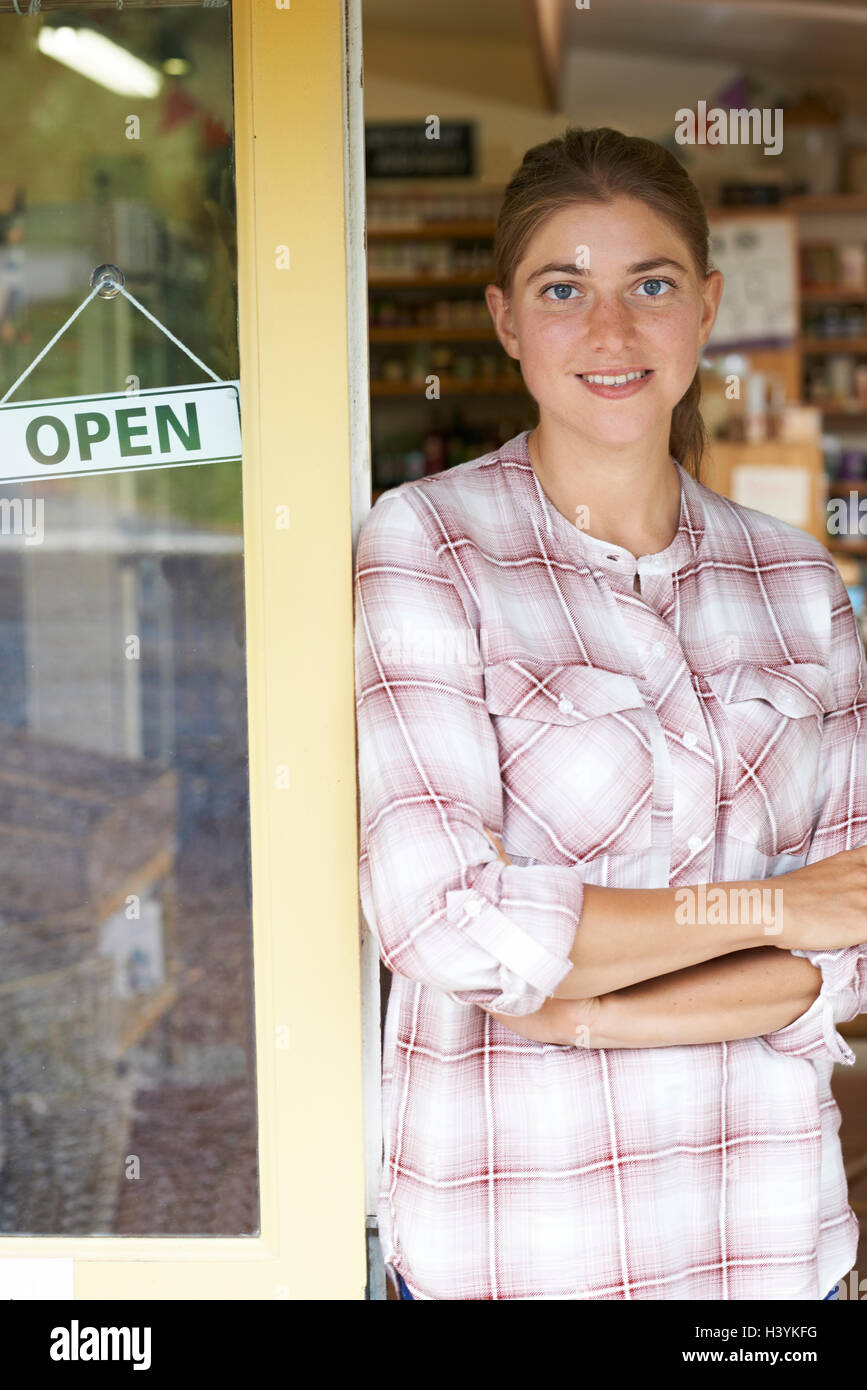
[766,566,867,1065]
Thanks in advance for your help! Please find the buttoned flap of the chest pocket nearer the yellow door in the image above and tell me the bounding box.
[485,657,645,724]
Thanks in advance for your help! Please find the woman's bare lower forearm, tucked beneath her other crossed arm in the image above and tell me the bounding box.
[584,947,821,1048]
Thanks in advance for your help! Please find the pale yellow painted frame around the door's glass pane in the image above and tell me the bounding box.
[0,0,370,1300]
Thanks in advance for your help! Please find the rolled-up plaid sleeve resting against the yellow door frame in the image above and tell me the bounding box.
[354,488,584,1015]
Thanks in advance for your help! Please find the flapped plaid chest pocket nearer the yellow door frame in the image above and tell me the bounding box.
[485,659,656,865]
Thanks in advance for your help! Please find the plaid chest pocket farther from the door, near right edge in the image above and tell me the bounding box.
[704,662,832,856]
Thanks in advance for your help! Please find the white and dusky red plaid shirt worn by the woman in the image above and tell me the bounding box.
[356,431,867,1300]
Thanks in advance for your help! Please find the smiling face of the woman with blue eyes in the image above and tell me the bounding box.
[485,197,723,450]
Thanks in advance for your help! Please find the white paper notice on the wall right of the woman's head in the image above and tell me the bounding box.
[707,214,799,350]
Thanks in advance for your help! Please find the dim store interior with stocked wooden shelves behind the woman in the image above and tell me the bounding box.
[363,0,867,1297]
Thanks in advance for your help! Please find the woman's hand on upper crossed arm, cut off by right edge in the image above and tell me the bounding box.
[763,845,867,951]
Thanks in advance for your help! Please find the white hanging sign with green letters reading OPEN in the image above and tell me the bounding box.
[0,381,240,482]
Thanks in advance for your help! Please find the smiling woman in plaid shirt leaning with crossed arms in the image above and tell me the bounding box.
[356,128,867,1300]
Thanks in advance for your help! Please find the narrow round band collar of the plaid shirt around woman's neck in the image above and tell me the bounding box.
[499,430,704,575]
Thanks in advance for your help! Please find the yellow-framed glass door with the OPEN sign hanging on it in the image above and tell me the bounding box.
[0,0,366,1300]
